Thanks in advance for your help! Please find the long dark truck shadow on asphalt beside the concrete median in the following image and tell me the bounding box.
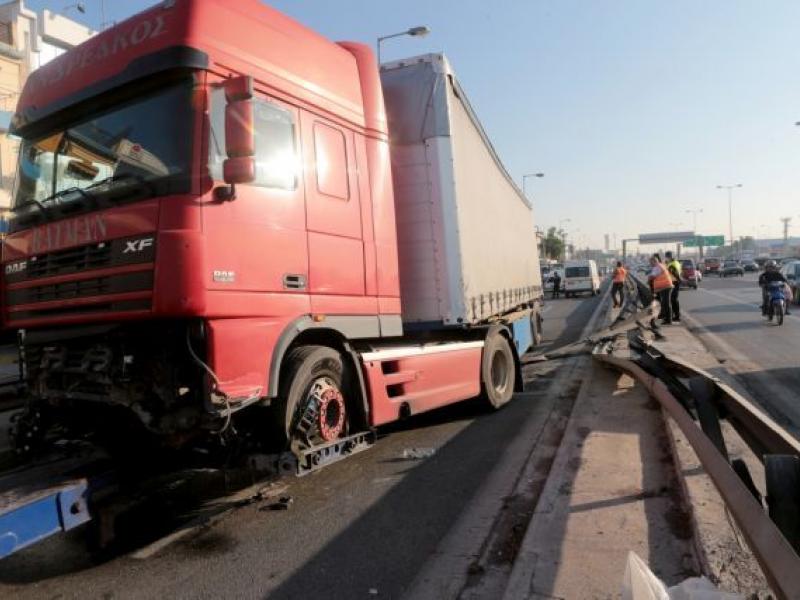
[267,382,552,599]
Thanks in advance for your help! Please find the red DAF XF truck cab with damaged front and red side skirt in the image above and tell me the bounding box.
[2,0,540,460]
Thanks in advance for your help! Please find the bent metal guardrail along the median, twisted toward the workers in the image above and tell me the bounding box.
[592,277,800,599]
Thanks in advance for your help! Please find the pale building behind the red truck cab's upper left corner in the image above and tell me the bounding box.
[0,0,96,231]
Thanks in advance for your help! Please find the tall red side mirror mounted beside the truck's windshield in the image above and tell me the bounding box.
[217,76,256,200]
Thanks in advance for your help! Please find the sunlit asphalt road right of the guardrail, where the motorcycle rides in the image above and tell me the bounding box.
[680,273,800,437]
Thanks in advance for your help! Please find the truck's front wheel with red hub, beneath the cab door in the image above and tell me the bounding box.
[274,346,350,447]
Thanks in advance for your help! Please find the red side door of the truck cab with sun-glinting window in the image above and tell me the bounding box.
[203,81,308,304]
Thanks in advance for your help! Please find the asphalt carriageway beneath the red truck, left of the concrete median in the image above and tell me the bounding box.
[0,298,598,599]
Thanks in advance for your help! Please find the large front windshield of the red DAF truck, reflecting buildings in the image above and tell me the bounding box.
[14,80,192,216]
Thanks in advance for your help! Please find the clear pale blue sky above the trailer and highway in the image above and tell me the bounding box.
[26,0,800,247]
